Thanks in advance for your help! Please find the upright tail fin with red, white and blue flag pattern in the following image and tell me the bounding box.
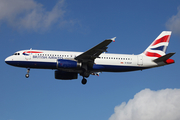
[141,31,171,57]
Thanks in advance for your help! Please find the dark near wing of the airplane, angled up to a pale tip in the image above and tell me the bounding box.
[75,37,116,63]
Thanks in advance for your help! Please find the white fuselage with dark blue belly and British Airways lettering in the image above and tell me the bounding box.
[5,50,162,72]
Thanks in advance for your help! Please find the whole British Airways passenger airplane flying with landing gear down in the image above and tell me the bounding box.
[5,31,175,85]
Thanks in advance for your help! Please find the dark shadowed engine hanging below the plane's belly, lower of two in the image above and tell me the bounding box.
[55,70,78,80]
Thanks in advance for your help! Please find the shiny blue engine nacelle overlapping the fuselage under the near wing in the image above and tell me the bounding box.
[57,59,81,68]
